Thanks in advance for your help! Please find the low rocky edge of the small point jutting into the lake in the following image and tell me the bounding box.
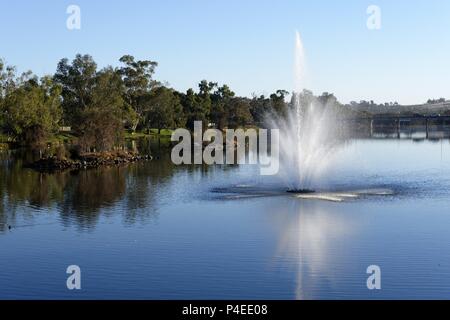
[26,151,152,171]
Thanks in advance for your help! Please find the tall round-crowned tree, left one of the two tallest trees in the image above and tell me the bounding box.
[54,54,97,125]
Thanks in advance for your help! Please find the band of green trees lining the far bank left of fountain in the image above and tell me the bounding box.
[0,54,354,159]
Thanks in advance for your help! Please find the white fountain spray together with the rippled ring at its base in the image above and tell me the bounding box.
[214,32,393,202]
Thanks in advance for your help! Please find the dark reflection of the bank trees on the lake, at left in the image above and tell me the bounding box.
[0,139,189,232]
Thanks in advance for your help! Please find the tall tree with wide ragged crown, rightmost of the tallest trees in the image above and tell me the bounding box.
[119,55,158,131]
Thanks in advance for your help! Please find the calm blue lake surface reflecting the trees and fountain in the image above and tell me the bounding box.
[0,139,450,299]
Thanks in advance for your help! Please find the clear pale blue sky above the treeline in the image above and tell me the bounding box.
[0,0,450,104]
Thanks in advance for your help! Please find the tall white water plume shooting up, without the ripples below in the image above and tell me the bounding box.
[268,32,348,192]
